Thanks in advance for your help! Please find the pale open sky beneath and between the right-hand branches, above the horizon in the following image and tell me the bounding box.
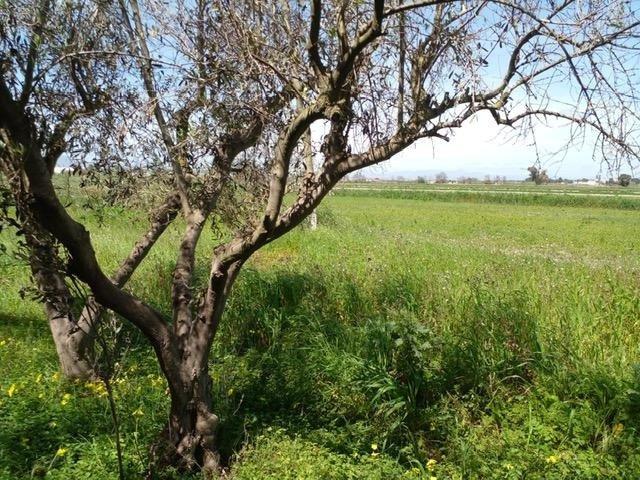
[364,0,640,180]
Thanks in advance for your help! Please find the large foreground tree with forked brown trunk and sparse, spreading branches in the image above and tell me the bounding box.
[0,0,640,475]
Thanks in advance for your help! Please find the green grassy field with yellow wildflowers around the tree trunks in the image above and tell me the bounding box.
[0,184,640,480]
